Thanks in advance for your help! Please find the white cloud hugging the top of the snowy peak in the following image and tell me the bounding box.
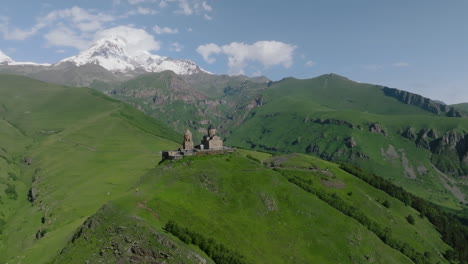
[94,26,161,52]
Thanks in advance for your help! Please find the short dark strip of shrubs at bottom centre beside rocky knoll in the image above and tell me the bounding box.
[164,220,248,264]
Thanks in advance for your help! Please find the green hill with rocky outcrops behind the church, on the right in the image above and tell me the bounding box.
[227,74,468,210]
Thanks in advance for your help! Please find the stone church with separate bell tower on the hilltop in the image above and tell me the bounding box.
[162,125,235,160]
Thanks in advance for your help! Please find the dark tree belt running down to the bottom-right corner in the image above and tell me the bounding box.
[340,163,468,264]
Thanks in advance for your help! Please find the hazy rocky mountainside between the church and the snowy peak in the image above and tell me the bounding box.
[92,71,268,138]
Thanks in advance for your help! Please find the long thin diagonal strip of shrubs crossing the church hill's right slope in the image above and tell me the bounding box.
[277,170,430,264]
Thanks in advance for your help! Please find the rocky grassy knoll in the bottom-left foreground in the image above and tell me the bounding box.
[52,202,213,264]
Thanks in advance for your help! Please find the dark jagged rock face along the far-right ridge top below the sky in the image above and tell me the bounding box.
[382,87,466,117]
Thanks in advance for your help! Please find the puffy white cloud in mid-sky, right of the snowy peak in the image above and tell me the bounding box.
[197,41,297,74]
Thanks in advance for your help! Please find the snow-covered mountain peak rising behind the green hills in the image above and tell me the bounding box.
[57,37,206,75]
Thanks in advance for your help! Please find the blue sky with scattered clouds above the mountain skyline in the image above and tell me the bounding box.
[0,0,468,103]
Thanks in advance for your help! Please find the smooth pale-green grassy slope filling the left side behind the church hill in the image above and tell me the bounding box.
[0,75,178,263]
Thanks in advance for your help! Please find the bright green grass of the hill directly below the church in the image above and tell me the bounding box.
[51,154,448,263]
